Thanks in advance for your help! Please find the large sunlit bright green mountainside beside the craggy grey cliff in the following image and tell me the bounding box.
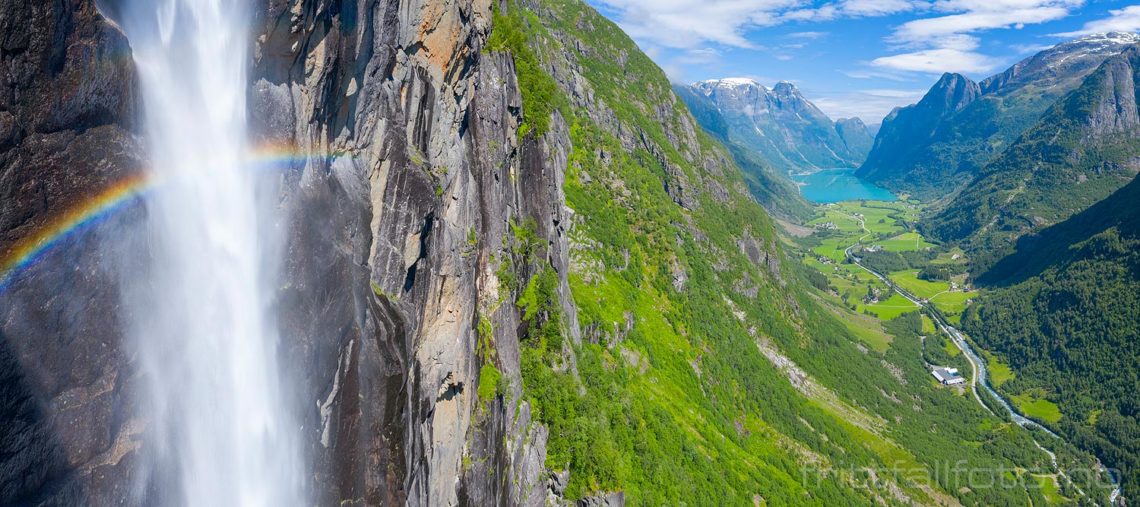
[497,0,1067,505]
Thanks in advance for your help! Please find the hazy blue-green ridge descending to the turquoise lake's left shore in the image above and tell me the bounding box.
[673,84,812,222]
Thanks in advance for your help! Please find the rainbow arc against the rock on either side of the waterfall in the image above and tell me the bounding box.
[0,145,360,293]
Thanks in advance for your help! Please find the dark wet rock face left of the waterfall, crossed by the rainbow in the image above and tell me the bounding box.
[0,0,141,505]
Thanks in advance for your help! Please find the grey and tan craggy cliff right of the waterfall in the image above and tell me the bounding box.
[253,0,577,505]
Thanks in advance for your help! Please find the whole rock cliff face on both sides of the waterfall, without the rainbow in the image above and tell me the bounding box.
[0,0,577,505]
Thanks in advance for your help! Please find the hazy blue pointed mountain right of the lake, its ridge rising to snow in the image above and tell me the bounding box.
[860,33,1140,201]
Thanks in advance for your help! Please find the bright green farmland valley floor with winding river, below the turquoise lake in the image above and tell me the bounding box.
[782,201,1113,505]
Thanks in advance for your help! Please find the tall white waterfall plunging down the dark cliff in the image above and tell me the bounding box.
[116,0,307,506]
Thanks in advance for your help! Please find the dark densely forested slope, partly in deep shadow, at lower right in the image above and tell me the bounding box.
[963,175,1140,498]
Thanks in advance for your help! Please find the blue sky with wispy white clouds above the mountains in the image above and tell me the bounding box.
[588,0,1140,123]
